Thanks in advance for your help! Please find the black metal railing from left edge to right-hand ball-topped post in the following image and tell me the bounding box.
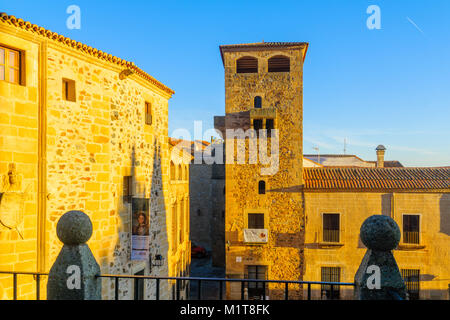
[0,271,355,300]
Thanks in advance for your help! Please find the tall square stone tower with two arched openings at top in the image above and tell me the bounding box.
[215,42,308,299]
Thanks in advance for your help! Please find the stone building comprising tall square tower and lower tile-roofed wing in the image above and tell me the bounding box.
[215,43,450,299]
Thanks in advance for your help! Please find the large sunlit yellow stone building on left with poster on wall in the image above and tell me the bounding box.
[0,13,189,299]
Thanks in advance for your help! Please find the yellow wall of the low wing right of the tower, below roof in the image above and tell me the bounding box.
[304,192,450,299]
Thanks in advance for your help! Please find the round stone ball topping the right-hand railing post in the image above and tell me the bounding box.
[360,215,400,251]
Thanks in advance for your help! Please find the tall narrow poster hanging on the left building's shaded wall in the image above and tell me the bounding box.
[131,198,150,260]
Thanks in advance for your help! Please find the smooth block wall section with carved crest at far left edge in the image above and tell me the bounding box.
[0,23,41,300]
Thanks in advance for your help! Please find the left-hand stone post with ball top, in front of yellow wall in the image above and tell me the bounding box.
[47,211,102,300]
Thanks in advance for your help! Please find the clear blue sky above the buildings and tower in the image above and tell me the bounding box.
[0,0,450,166]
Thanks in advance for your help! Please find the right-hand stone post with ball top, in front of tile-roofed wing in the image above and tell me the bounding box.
[355,215,407,300]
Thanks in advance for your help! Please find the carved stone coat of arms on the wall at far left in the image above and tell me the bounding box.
[0,163,29,239]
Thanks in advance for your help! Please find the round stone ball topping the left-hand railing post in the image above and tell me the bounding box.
[56,211,92,245]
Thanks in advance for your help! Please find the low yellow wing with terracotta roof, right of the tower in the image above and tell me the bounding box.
[303,167,450,299]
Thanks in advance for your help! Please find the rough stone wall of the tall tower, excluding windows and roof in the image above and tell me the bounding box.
[223,45,310,299]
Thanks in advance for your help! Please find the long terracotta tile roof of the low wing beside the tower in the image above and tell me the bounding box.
[303,167,450,191]
